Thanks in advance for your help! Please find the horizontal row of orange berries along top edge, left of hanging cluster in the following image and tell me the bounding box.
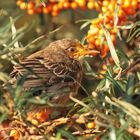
[17,0,99,16]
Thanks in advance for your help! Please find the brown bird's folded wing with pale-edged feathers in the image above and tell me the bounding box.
[11,57,81,89]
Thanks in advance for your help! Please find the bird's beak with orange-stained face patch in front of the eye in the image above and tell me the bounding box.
[74,45,100,58]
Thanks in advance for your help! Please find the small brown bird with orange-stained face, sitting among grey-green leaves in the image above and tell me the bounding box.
[11,39,98,105]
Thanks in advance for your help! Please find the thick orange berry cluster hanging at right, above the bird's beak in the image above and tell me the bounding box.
[87,0,140,57]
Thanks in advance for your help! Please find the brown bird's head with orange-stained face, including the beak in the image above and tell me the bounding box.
[51,39,99,59]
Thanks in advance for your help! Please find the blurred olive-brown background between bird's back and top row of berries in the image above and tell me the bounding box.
[0,0,97,44]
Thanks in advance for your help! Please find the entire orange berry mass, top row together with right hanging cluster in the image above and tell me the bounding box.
[17,0,140,57]
